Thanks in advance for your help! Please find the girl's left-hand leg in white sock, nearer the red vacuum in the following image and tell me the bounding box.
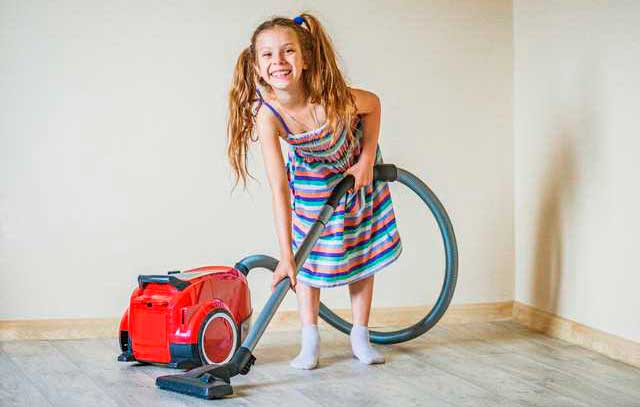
[290,281,320,369]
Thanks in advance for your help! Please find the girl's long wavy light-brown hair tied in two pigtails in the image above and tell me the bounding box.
[227,13,356,187]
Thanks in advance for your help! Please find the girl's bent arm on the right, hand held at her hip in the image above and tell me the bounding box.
[346,88,381,191]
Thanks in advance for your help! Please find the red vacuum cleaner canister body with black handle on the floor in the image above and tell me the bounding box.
[118,266,252,368]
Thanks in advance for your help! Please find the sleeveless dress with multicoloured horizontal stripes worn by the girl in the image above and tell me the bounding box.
[255,94,402,287]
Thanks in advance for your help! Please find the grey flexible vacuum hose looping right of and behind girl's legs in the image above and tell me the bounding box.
[320,168,458,344]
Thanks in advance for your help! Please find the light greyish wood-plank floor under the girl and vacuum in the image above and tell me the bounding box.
[0,322,640,407]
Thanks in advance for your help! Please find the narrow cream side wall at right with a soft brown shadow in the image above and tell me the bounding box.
[514,0,640,341]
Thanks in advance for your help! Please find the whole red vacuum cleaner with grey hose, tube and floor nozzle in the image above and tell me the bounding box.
[118,164,458,399]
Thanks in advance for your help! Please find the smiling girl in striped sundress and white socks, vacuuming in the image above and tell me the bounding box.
[228,14,402,369]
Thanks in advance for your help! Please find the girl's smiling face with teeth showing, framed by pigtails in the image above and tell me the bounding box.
[256,27,307,90]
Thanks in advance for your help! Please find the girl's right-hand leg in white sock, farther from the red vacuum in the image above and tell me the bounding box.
[349,276,384,365]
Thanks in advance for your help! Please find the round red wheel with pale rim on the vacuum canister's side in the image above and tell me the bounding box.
[198,309,240,365]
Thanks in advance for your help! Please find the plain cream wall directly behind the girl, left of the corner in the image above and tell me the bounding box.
[0,0,514,319]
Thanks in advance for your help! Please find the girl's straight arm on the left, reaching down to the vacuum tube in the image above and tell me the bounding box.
[256,108,296,287]
